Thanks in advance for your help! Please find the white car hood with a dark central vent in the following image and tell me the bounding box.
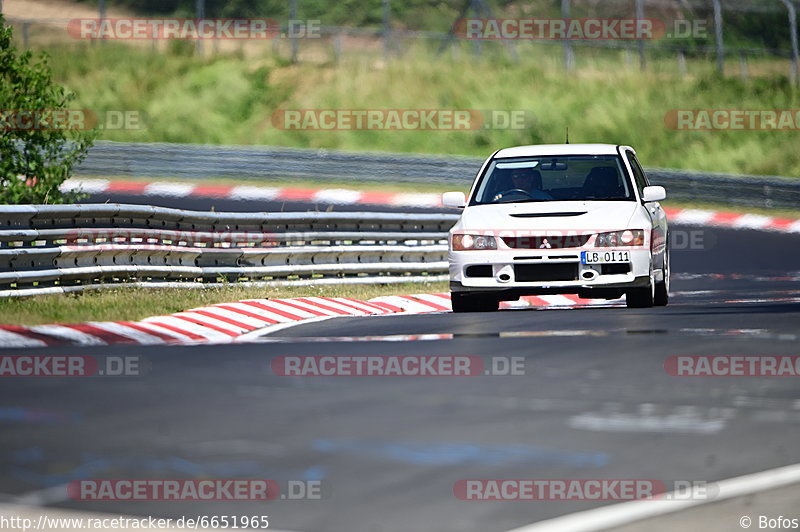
[453,201,640,231]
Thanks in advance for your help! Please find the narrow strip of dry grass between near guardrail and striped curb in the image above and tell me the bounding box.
[0,282,448,326]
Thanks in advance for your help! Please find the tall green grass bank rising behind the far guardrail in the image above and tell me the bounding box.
[31,43,800,176]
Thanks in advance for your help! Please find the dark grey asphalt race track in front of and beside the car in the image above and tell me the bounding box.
[0,193,800,532]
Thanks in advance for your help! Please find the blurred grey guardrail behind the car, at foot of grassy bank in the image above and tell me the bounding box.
[76,142,800,208]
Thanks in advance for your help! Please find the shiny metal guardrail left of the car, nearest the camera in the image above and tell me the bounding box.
[0,204,458,297]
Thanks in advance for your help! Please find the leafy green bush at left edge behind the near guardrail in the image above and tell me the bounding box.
[0,14,97,204]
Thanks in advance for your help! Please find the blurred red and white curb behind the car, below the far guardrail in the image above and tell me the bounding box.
[61,179,800,233]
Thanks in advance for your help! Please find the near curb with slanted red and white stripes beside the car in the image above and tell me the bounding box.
[0,293,619,348]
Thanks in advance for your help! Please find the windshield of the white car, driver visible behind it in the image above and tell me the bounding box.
[472,155,635,205]
